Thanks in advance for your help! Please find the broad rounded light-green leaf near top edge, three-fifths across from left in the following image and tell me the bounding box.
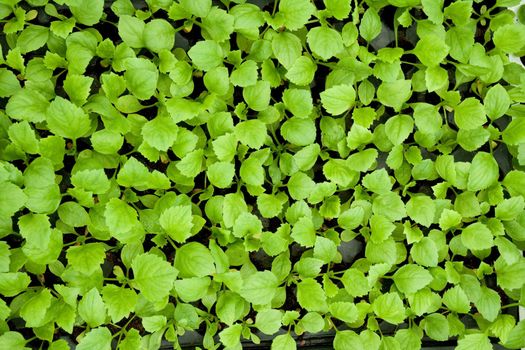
[306,26,344,61]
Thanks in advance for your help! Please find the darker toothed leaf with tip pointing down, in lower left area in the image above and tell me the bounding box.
[66,243,106,276]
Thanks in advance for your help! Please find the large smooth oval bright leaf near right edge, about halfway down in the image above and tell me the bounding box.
[467,152,499,191]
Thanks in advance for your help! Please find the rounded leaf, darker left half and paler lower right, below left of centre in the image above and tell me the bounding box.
[174,242,215,278]
